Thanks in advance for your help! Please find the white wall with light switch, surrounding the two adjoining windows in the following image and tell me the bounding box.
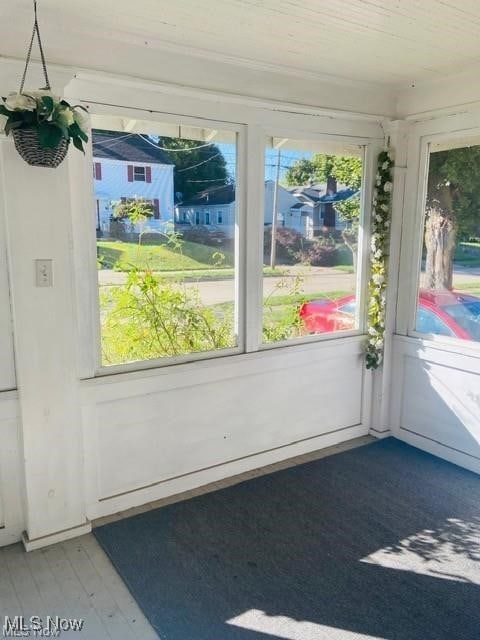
[0,67,383,546]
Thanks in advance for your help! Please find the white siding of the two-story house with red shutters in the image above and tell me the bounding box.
[93,157,174,232]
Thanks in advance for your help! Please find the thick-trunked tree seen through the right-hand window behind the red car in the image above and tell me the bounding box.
[425,146,480,290]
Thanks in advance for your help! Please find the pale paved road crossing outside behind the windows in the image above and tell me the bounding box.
[98,267,480,305]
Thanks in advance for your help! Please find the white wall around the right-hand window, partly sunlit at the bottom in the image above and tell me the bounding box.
[389,111,480,472]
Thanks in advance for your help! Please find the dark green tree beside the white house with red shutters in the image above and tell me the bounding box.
[158,138,230,200]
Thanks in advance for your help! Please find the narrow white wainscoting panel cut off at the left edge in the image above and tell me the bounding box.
[0,392,25,546]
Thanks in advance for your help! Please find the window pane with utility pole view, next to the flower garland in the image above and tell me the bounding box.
[263,138,363,343]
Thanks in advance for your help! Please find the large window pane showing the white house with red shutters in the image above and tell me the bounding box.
[92,117,238,366]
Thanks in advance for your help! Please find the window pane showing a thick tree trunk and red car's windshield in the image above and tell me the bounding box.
[416,145,480,341]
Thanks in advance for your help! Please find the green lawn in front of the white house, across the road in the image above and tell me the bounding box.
[97,240,233,271]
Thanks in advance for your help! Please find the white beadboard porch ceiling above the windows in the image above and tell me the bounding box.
[0,0,480,88]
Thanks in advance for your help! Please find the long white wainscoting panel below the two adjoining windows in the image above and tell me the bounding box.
[82,339,368,518]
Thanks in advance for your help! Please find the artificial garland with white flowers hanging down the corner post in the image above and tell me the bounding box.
[365,151,393,369]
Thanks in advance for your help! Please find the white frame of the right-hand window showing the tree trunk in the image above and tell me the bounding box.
[396,122,480,357]
